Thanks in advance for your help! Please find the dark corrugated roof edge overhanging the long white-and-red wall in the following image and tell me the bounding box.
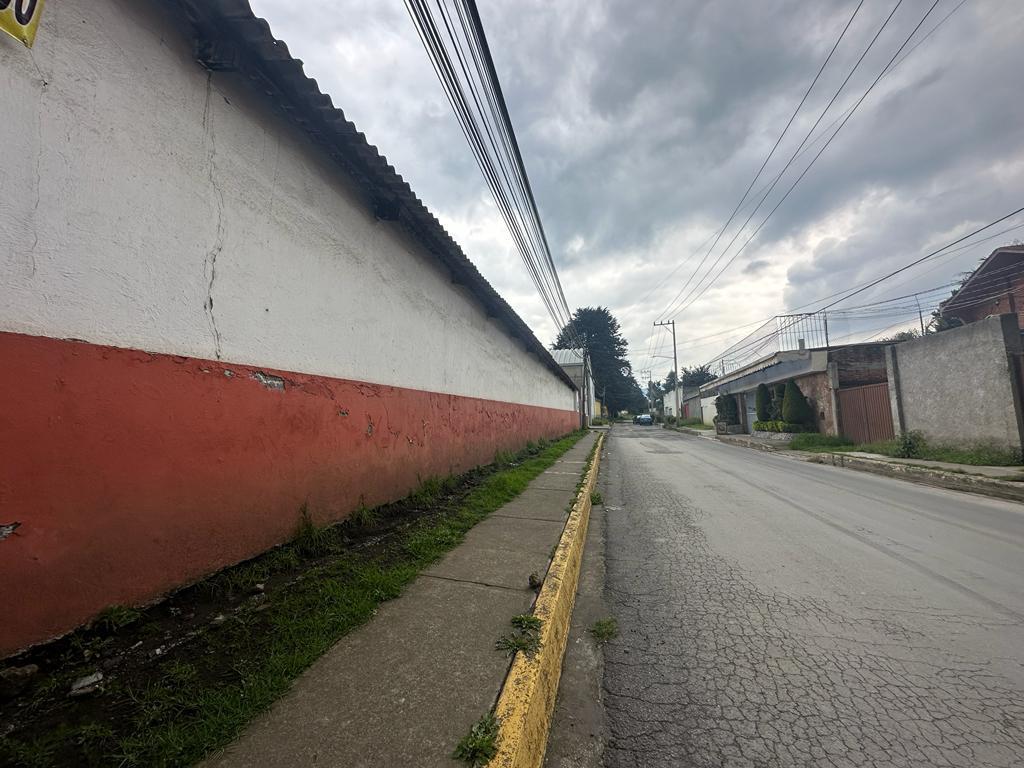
[164,0,577,389]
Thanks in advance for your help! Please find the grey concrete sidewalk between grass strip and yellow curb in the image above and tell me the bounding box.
[203,433,597,768]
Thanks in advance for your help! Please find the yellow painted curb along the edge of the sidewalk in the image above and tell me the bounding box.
[488,433,604,768]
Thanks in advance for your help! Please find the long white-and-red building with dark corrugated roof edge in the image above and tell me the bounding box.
[0,0,579,655]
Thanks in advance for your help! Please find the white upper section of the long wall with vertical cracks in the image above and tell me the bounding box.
[0,0,573,410]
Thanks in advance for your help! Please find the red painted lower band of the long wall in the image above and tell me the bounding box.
[0,333,578,657]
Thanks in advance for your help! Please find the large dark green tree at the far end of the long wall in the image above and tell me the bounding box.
[554,307,646,414]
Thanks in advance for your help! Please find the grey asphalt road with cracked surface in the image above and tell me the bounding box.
[604,426,1024,768]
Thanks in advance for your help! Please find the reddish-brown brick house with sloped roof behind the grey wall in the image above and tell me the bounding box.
[939,246,1024,327]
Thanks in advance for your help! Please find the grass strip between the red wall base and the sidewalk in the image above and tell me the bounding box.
[0,431,585,768]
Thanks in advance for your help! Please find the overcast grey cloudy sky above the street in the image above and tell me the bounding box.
[252,0,1024,378]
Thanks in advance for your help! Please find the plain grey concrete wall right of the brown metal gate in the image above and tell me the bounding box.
[886,314,1024,450]
